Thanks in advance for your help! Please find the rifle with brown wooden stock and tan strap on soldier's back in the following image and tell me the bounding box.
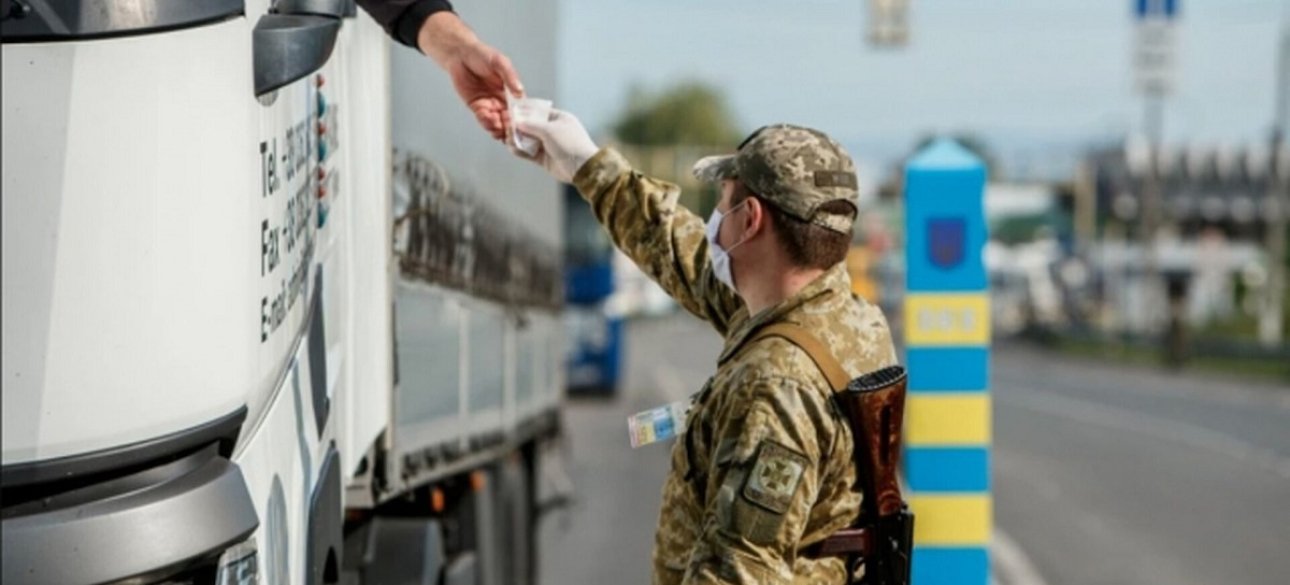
[749,323,913,585]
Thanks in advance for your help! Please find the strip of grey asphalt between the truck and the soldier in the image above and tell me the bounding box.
[538,316,721,585]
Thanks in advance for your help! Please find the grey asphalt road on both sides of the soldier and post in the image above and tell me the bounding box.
[539,315,1290,585]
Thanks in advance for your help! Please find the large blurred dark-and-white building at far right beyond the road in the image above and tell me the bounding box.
[1080,141,1290,333]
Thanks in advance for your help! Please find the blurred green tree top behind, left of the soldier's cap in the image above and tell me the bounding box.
[613,81,739,146]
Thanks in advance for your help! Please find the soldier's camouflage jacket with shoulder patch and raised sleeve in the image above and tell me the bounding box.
[574,149,895,584]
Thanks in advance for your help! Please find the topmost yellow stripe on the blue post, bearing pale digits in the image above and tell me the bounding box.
[904,293,989,346]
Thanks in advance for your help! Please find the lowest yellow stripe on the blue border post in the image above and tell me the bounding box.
[909,493,992,546]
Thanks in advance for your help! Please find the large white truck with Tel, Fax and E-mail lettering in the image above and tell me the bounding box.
[0,0,562,585]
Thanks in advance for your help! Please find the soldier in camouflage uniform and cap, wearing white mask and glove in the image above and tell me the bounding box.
[520,111,895,584]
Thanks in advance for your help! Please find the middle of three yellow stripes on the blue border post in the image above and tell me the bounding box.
[904,393,991,446]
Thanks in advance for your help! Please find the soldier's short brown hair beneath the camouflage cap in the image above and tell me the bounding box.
[730,180,855,270]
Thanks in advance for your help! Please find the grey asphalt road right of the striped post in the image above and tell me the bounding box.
[993,340,1290,585]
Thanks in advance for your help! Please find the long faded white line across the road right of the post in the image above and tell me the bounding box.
[996,390,1290,479]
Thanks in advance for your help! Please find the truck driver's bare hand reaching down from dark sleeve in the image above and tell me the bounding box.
[417,10,524,141]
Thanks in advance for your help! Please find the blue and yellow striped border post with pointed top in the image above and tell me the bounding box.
[904,139,993,585]
